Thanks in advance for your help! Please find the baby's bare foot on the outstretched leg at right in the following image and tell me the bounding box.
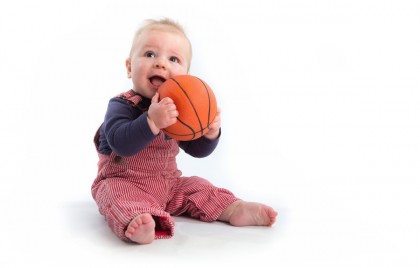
[219,200,277,226]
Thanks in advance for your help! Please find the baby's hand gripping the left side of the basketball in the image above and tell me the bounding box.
[147,93,178,135]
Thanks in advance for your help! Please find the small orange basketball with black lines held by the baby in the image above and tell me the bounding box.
[158,75,217,141]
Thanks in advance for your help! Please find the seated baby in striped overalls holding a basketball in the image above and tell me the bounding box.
[92,19,277,244]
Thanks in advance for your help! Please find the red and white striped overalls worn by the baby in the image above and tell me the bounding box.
[92,91,238,241]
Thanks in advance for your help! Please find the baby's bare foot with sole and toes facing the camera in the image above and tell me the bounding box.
[125,213,156,244]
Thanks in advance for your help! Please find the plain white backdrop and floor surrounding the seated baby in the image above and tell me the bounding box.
[0,0,420,267]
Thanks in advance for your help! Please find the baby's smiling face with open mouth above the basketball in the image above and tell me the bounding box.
[126,30,191,98]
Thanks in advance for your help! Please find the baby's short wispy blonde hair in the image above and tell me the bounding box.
[128,18,192,66]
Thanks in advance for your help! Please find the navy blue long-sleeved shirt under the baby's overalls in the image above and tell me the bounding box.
[98,93,220,157]
